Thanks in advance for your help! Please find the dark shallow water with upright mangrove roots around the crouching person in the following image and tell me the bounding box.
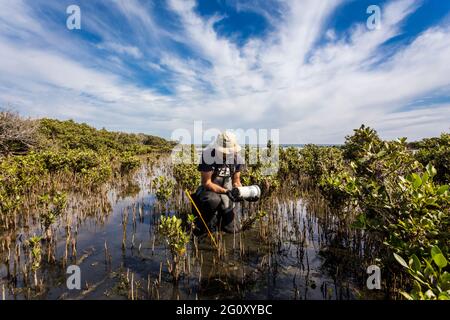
[0,161,380,299]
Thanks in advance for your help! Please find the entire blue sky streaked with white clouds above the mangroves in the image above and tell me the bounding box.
[0,0,450,143]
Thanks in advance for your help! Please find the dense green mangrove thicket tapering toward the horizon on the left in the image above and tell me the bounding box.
[0,111,175,220]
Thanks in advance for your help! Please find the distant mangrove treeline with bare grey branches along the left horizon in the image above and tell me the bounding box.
[0,111,175,155]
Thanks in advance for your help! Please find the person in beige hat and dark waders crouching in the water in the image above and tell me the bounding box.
[195,131,243,233]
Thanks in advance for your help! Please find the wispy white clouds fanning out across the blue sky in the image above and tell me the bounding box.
[0,0,450,143]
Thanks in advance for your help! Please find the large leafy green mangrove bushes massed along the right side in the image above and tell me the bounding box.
[282,126,450,299]
